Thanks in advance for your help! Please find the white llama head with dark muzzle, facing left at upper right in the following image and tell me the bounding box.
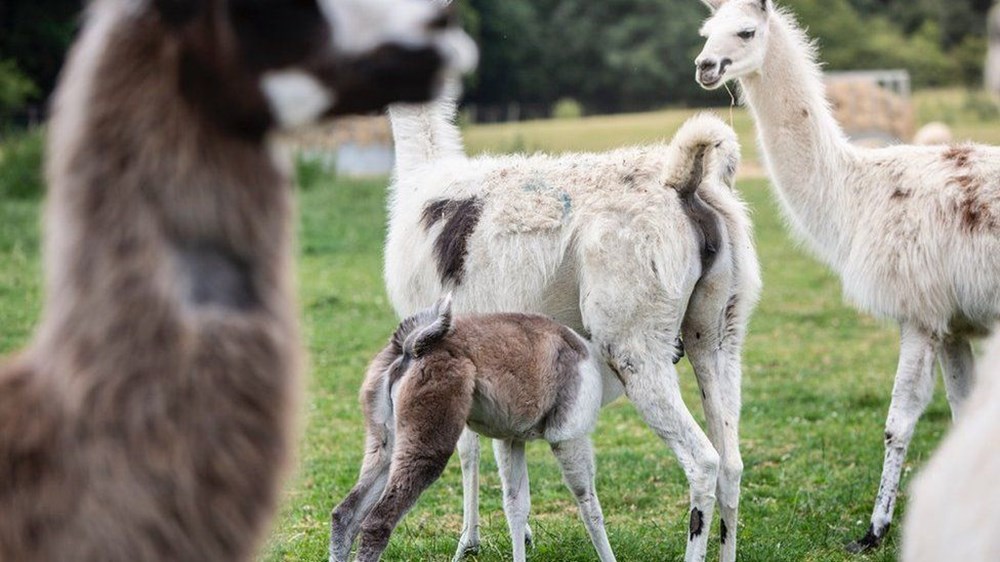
[694,0,774,90]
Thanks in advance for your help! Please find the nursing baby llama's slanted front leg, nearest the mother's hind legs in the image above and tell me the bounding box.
[552,437,615,562]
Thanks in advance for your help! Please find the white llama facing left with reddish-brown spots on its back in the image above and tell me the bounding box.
[695,0,1000,551]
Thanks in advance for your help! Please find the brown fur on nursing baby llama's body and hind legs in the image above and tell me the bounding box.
[331,312,589,561]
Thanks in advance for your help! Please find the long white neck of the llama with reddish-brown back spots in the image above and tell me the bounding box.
[740,10,852,265]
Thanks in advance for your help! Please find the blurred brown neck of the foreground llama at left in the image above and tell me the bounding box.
[36,12,294,372]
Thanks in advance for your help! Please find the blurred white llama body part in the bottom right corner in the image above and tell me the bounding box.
[902,328,1000,562]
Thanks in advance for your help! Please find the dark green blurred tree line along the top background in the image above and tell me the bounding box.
[0,0,992,124]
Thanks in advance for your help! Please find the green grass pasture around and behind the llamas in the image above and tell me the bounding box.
[0,92,1000,562]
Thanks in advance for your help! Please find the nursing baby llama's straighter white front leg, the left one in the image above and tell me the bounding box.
[493,439,531,562]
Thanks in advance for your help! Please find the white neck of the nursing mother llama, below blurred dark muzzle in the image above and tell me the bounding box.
[389,85,465,174]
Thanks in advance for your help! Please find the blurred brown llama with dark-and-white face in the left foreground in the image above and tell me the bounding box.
[0,0,472,562]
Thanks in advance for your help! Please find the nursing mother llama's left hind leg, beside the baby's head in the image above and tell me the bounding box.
[604,344,719,562]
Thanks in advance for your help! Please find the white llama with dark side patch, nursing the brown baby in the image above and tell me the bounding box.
[368,94,760,561]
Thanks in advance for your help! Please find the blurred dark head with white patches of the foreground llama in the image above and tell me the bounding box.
[133,0,476,127]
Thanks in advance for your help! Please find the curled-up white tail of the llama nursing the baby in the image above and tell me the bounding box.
[664,113,740,196]
